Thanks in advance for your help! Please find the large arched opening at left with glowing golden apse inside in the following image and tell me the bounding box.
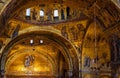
[1,27,79,78]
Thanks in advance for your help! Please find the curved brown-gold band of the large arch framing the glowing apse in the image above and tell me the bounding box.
[1,26,79,71]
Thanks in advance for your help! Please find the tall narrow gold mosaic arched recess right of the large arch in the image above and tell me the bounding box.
[82,22,111,78]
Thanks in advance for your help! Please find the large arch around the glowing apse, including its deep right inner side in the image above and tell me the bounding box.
[1,27,79,78]
